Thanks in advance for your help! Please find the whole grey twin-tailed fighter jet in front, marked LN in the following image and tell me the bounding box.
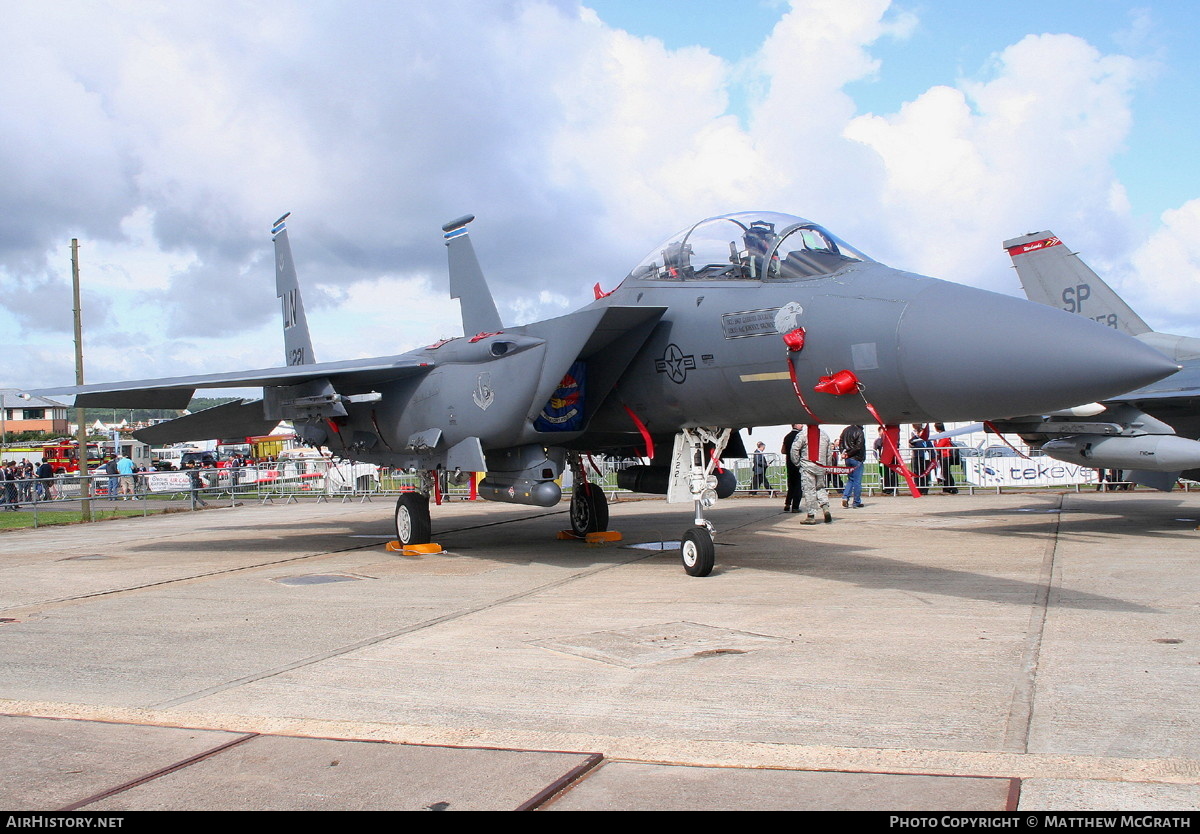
[32,211,1176,576]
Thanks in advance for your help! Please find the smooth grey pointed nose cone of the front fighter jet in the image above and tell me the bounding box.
[898,281,1178,420]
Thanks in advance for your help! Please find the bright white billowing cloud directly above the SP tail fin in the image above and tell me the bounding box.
[846,35,1140,288]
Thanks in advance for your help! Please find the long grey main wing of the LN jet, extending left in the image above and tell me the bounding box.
[30,355,433,409]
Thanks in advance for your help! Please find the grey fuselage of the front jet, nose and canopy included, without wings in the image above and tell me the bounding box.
[313,215,1172,463]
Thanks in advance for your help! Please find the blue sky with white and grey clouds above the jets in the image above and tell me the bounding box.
[0,0,1200,388]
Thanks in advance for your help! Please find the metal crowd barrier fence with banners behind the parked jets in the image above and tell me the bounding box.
[0,449,1180,526]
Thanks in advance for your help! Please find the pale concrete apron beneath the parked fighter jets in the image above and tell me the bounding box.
[0,493,1200,810]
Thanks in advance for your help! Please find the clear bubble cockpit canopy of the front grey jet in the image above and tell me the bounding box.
[629,211,871,281]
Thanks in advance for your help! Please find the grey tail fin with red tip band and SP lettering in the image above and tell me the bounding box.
[1004,232,1150,336]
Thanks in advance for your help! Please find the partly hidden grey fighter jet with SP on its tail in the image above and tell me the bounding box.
[996,232,1200,491]
